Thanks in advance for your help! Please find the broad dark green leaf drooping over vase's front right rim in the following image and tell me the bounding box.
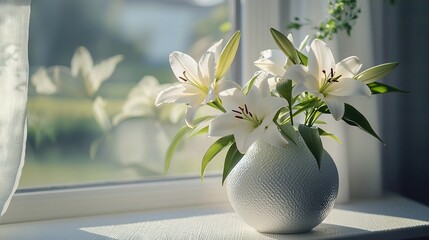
[298,124,323,169]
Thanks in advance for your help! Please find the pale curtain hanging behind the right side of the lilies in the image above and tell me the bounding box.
[289,0,384,202]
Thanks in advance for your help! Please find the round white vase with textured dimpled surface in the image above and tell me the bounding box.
[226,139,338,233]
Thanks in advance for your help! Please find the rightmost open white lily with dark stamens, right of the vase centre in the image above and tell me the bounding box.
[284,39,371,120]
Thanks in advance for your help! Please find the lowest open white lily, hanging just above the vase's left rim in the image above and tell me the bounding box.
[209,86,286,154]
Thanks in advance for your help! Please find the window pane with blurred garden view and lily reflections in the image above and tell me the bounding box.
[20,0,229,188]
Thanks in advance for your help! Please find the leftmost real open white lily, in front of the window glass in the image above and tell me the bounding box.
[155,40,237,126]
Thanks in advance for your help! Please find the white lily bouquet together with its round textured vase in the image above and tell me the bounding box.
[156,29,401,232]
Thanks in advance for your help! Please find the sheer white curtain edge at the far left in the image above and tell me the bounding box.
[0,0,30,215]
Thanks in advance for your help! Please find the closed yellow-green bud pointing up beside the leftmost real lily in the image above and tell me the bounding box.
[215,31,240,80]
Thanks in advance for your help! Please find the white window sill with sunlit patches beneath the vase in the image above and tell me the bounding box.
[0,196,429,240]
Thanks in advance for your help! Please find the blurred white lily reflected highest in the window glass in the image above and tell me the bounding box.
[71,47,123,96]
